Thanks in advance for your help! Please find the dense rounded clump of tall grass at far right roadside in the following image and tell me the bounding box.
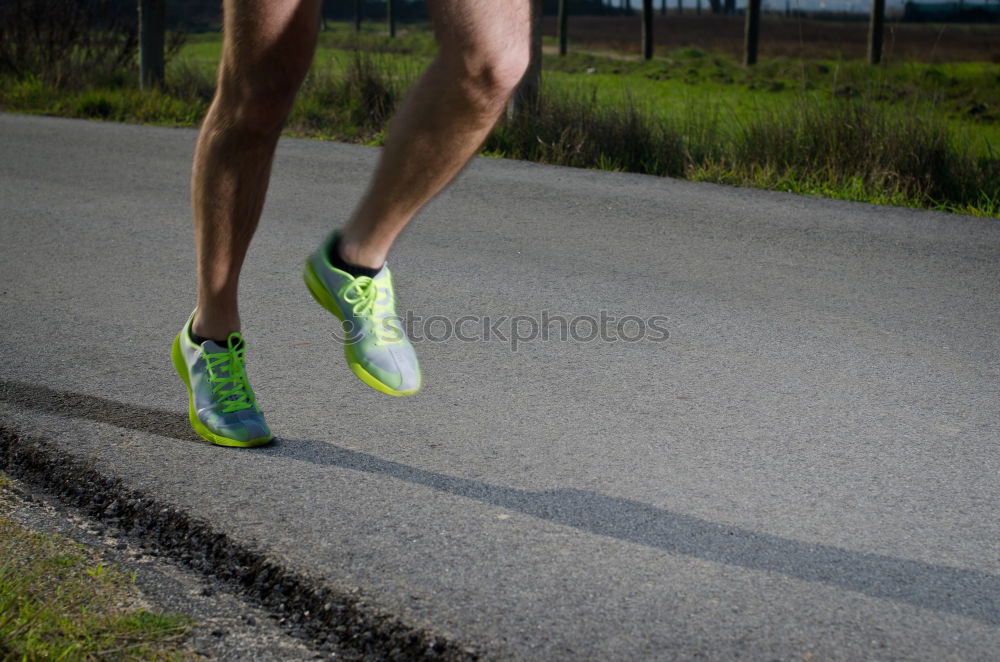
[712,95,1000,207]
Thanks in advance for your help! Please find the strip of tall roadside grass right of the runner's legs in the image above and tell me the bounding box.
[485,81,1000,212]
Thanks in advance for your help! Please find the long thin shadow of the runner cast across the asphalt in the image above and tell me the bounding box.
[0,380,1000,625]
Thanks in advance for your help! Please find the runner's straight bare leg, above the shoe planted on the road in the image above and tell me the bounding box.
[191,0,320,338]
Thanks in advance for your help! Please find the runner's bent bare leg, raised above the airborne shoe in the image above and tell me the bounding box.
[340,0,531,268]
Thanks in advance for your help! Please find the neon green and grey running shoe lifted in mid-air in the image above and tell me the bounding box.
[304,234,420,395]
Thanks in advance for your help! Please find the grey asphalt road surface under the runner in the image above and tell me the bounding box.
[0,115,1000,661]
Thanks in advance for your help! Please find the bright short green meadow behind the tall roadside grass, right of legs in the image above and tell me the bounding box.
[545,48,1000,161]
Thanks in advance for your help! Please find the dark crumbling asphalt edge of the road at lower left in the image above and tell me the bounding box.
[0,416,486,662]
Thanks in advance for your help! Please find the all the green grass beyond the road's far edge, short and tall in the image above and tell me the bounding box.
[0,20,1000,217]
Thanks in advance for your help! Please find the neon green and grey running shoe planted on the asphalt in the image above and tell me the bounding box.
[171,313,274,447]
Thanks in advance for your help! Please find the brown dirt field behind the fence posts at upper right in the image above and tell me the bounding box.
[544,10,1000,63]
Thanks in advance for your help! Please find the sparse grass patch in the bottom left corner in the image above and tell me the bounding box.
[0,474,195,662]
